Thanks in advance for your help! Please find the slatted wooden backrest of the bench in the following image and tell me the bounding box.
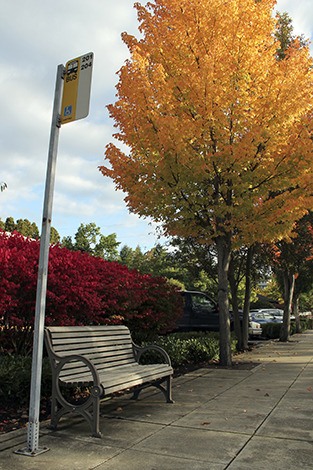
[45,325,136,377]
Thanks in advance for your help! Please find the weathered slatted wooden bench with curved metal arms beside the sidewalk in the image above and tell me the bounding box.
[45,325,173,437]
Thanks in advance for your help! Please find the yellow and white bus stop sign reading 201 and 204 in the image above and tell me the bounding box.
[61,52,93,124]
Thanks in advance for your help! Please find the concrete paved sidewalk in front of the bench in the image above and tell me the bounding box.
[0,331,313,470]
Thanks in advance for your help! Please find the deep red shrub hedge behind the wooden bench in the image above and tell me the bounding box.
[0,231,182,340]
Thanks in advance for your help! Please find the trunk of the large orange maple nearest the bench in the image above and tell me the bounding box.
[216,235,232,366]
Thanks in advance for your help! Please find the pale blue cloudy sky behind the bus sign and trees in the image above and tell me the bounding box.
[0,0,313,251]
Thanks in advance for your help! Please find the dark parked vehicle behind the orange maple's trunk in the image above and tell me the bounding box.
[176,291,262,336]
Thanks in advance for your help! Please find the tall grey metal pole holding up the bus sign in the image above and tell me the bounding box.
[16,64,65,457]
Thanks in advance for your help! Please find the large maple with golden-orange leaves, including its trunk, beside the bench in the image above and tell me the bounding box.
[100,0,313,364]
